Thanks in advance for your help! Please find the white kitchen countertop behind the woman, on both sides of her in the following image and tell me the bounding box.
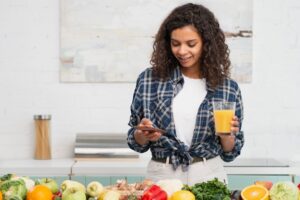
[0,158,300,176]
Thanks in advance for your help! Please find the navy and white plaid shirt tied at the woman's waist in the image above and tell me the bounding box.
[127,67,244,171]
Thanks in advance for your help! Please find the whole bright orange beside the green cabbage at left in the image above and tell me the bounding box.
[26,185,52,200]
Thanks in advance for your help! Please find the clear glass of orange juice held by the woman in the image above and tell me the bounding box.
[213,101,235,135]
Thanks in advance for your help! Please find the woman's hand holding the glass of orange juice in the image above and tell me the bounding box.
[219,116,240,152]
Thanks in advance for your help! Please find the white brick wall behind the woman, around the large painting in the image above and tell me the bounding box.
[0,0,300,160]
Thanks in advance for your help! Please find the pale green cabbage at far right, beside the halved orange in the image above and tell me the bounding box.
[270,181,299,200]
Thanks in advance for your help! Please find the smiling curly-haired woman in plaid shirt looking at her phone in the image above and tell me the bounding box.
[128,3,244,185]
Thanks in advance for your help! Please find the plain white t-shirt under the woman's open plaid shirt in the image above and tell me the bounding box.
[173,76,207,146]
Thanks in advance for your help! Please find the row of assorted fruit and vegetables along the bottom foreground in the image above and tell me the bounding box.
[0,174,300,200]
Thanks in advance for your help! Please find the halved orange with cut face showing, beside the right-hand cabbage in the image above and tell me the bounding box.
[241,185,269,200]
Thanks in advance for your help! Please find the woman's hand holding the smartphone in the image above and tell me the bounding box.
[134,118,161,145]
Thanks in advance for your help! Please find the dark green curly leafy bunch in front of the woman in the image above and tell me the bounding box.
[183,178,230,200]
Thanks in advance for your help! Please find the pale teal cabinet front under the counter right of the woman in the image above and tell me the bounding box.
[228,175,292,190]
